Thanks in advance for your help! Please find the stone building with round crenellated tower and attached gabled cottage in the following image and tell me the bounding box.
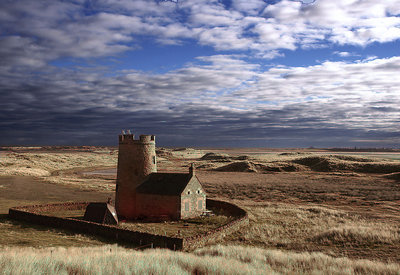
[115,132,206,220]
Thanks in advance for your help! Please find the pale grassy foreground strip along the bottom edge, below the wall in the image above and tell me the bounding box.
[0,246,400,274]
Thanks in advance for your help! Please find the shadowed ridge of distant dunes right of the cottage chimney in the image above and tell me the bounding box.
[197,153,400,174]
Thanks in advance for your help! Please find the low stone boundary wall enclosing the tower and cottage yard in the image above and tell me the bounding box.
[8,199,249,251]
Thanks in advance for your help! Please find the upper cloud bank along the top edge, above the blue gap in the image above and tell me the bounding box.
[0,0,400,65]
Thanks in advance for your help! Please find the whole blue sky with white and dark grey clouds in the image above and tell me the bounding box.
[0,0,400,148]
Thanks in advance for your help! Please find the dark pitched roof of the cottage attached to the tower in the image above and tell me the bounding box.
[136,173,191,196]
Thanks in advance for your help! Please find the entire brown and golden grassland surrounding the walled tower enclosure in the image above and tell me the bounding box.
[0,148,400,274]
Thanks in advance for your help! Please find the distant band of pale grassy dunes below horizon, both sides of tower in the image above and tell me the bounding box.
[0,148,400,191]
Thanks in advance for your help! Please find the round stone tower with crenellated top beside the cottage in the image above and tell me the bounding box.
[115,133,157,219]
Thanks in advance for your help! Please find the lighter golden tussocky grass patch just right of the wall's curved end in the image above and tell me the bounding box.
[230,203,400,247]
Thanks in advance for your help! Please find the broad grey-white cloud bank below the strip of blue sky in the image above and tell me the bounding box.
[0,49,400,147]
